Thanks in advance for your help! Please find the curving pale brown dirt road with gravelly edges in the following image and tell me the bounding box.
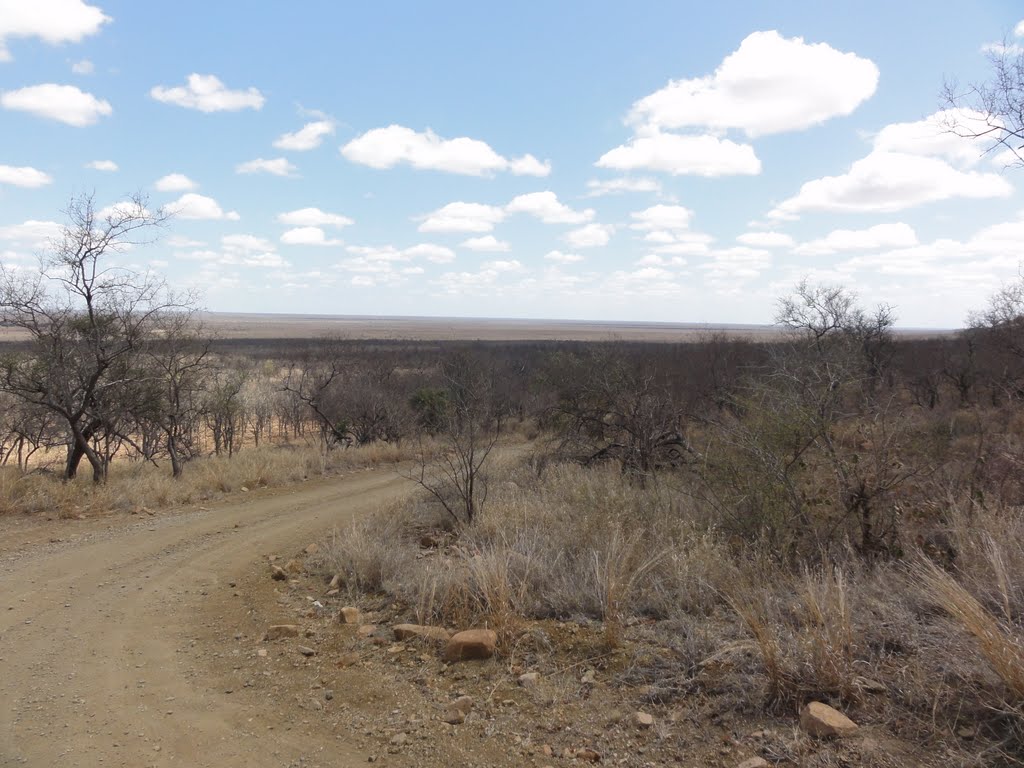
[0,470,410,768]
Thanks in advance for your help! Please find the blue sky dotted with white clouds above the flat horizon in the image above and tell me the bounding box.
[0,0,1024,327]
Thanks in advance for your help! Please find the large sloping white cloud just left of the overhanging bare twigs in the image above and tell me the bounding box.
[768,112,1013,219]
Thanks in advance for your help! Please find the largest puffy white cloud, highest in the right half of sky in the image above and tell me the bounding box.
[628,31,879,137]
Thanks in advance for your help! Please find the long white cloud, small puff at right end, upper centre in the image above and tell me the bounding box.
[341,125,551,176]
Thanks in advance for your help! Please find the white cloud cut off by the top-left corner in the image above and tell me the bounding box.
[0,0,111,61]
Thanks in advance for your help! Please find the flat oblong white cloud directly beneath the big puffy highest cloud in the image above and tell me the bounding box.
[597,132,761,176]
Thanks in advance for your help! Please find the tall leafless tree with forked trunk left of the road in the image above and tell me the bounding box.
[0,195,180,482]
